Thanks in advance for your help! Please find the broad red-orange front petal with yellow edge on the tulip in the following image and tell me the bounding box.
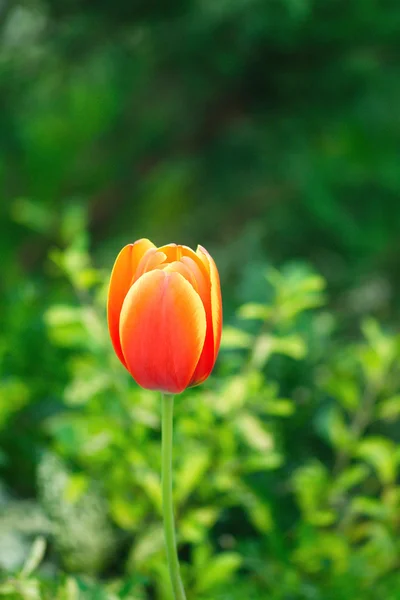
[120,269,206,394]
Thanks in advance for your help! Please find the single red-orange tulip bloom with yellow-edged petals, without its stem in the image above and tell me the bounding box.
[107,239,222,394]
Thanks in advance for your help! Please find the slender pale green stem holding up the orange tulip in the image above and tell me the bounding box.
[162,394,186,600]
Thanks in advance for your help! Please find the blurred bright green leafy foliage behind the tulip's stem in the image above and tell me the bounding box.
[0,214,400,600]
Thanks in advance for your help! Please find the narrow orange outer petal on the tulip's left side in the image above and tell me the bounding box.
[107,239,155,367]
